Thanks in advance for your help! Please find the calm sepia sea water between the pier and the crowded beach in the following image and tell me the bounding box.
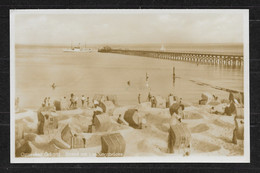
[15,47,244,109]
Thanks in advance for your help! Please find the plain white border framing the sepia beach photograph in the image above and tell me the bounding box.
[10,9,250,163]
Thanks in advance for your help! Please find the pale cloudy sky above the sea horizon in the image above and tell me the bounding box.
[15,12,243,45]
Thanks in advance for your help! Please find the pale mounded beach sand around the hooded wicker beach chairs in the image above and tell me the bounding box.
[15,98,244,157]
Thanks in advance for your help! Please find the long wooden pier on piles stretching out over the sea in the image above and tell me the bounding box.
[99,48,244,67]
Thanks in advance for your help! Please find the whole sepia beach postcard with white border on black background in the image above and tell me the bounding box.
[10,9,250,163]
